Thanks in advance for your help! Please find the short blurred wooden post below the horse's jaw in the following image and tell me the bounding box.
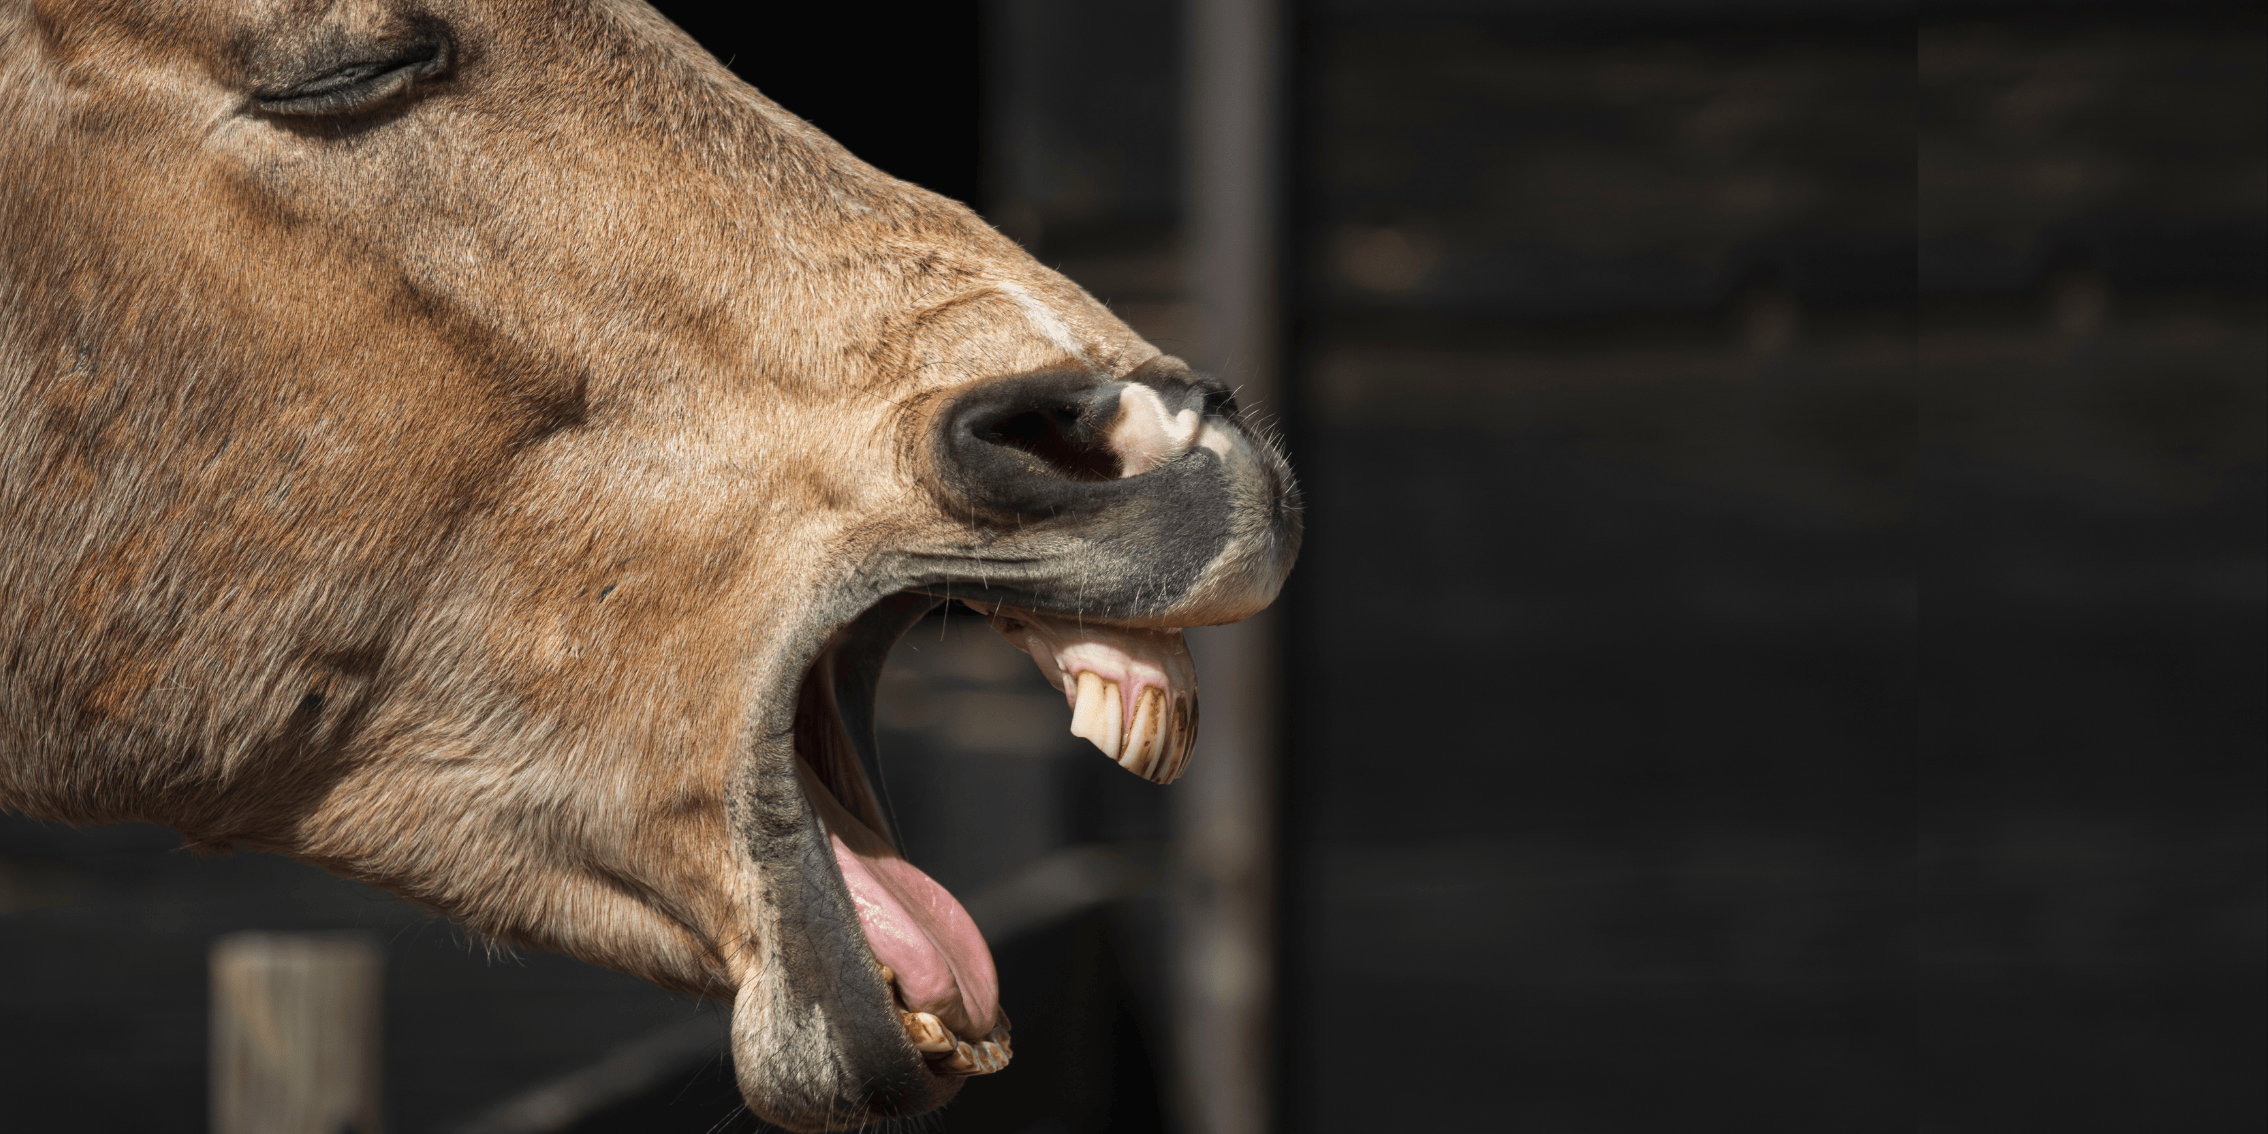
[211,932,383,1134]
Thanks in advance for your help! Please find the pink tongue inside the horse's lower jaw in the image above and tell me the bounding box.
[826,821,1000,1039]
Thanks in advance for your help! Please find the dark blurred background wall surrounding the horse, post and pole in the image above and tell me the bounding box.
[0,0,2268,1134]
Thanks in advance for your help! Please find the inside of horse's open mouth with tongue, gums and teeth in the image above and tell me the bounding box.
[794,592,1198,1075]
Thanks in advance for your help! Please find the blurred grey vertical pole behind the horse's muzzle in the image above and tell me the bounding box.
[1173,0,1284,1134]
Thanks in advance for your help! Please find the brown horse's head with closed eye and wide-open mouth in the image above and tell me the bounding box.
[0,0,1300,1129]
